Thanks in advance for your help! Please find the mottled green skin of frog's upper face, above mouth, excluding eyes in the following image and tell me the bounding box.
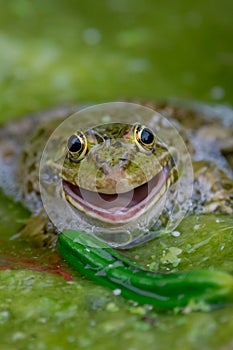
[63,123,177,194]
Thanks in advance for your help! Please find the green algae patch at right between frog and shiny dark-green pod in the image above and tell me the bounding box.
[125,214,233,273]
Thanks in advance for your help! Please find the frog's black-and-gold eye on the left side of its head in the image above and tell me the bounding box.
[67,131,87,162]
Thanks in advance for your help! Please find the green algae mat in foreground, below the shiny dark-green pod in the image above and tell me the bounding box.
[0,270,233,350]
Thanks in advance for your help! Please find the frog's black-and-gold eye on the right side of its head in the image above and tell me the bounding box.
[134,125,155,152]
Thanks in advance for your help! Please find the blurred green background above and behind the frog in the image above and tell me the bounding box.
[0,0,233,121]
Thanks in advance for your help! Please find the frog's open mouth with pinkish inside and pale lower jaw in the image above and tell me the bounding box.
[63,166,170,225]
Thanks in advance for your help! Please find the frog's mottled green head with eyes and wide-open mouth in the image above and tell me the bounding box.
[62,123,177,224]
